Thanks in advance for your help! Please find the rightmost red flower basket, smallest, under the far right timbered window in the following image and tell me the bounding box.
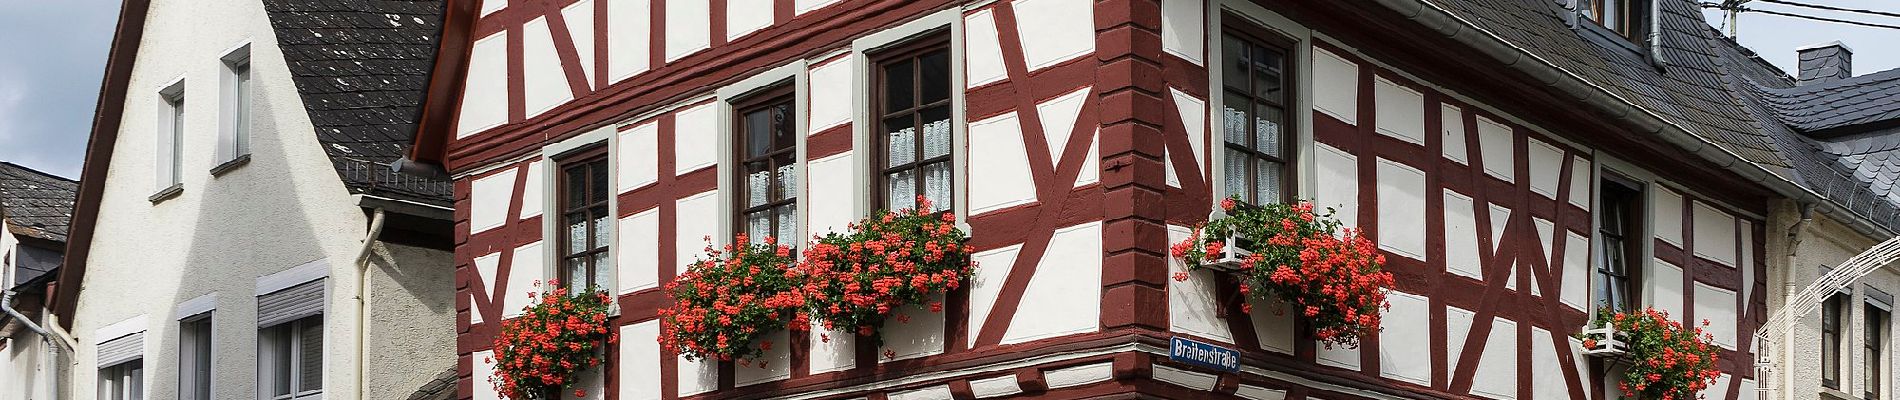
[1575,309,1721,398]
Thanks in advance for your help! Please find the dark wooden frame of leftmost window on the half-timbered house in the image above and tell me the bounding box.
[543,142,619,290]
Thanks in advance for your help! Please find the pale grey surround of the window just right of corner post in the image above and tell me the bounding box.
[1201,0,1314,210]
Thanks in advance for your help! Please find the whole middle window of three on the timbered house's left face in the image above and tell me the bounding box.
[733,87,800,245]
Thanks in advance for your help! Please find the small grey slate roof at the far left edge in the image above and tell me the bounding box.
[0,161,80,243]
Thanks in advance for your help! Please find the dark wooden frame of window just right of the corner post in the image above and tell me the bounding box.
[1207,13,1311,203]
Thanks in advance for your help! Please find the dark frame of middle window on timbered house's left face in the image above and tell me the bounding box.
[726,80,808,248]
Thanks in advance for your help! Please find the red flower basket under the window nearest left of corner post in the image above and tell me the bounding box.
[800,197,975,345]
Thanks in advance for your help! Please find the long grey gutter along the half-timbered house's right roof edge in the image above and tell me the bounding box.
[1374,0,1894,237]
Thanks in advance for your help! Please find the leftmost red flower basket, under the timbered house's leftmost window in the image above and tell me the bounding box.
[485,281,619,400]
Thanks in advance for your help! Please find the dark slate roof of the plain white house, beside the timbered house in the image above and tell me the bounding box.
[264,0,452,207]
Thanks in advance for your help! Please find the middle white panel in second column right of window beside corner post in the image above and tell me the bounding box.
[1378,157,1425,262]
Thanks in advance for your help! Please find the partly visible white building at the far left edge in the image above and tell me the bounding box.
[0,161,78,400]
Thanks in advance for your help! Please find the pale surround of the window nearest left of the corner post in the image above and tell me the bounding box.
[855,8,973,229]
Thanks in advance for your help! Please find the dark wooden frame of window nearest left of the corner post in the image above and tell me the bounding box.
[865,27,961,212]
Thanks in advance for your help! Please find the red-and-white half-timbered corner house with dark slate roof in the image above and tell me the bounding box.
[405,0,1894,400]
